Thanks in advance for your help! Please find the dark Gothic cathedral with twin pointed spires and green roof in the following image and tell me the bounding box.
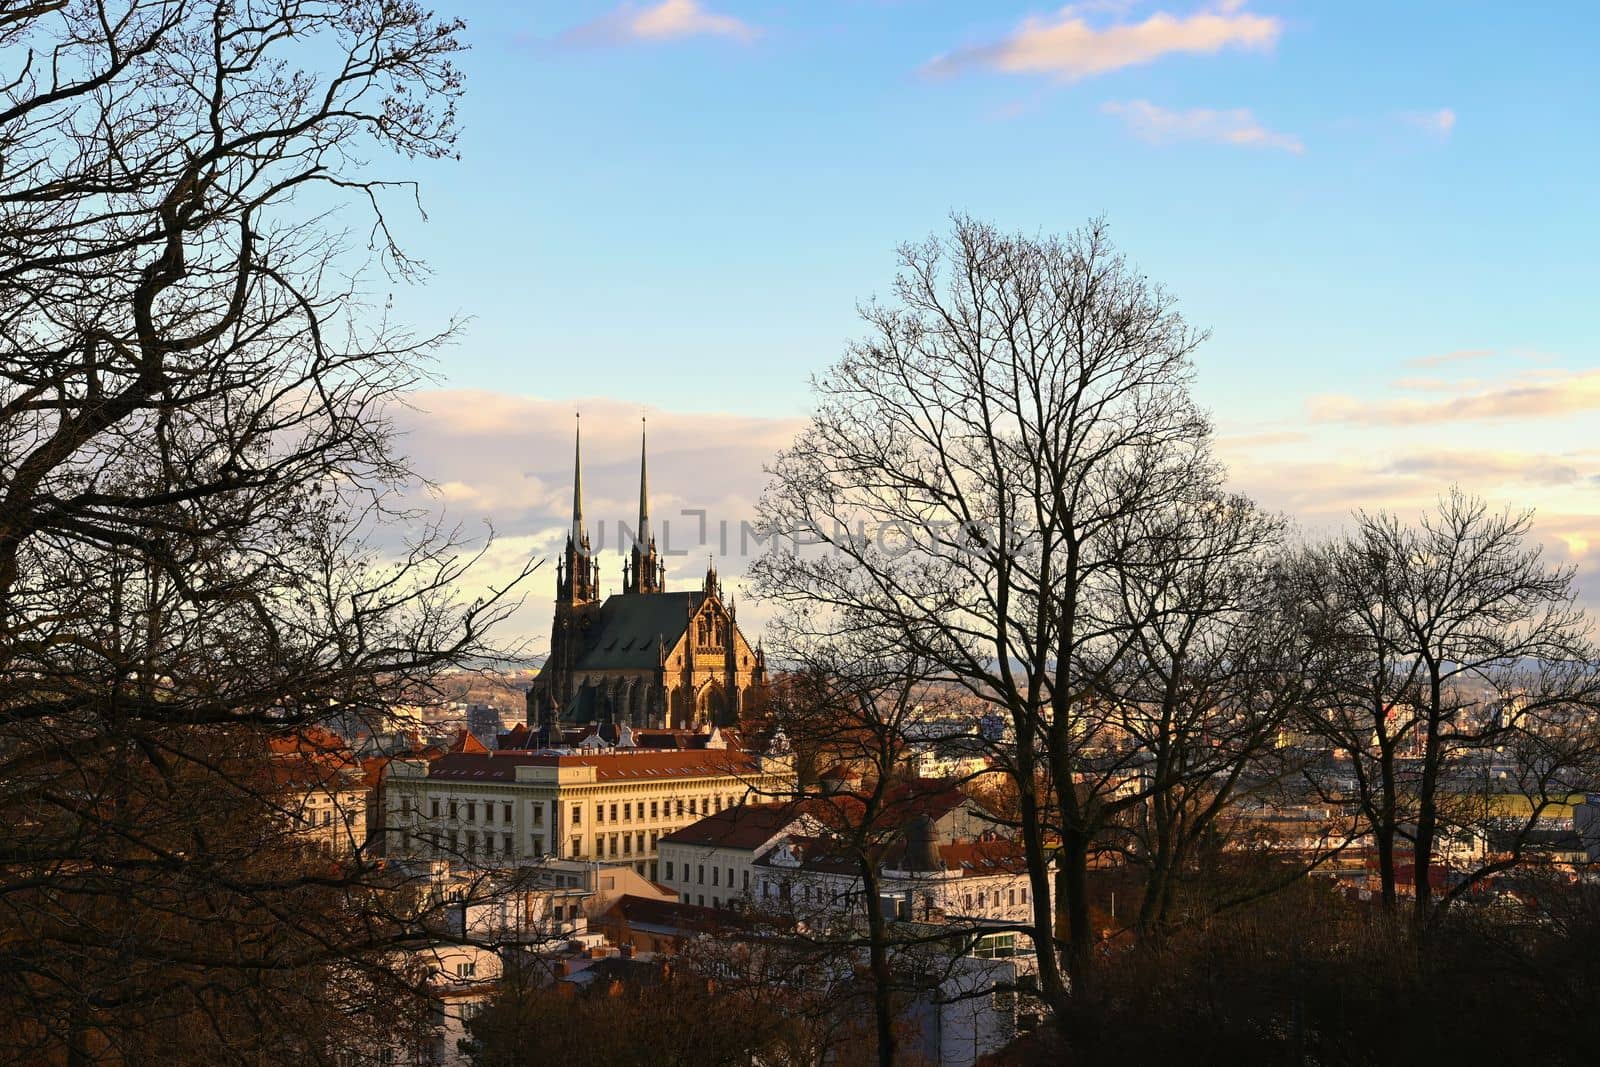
[528,432,766,729]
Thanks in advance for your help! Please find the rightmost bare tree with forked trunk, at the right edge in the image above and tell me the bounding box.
[1307,490,1600,925]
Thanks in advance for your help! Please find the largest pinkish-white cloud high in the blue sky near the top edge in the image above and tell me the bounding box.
[923,3,1282,82]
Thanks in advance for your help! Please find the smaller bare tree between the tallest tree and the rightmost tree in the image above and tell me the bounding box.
[1090,485,1320,931]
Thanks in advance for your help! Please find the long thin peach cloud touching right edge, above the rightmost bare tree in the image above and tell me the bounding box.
[1307,370,1600,426]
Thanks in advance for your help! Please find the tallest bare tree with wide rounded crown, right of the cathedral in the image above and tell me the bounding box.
[754,219,1214,1009]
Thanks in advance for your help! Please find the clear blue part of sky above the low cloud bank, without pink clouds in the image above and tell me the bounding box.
[393,0,1600,414]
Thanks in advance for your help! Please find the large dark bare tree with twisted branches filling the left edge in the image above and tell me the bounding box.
[0,0,537,1062]
